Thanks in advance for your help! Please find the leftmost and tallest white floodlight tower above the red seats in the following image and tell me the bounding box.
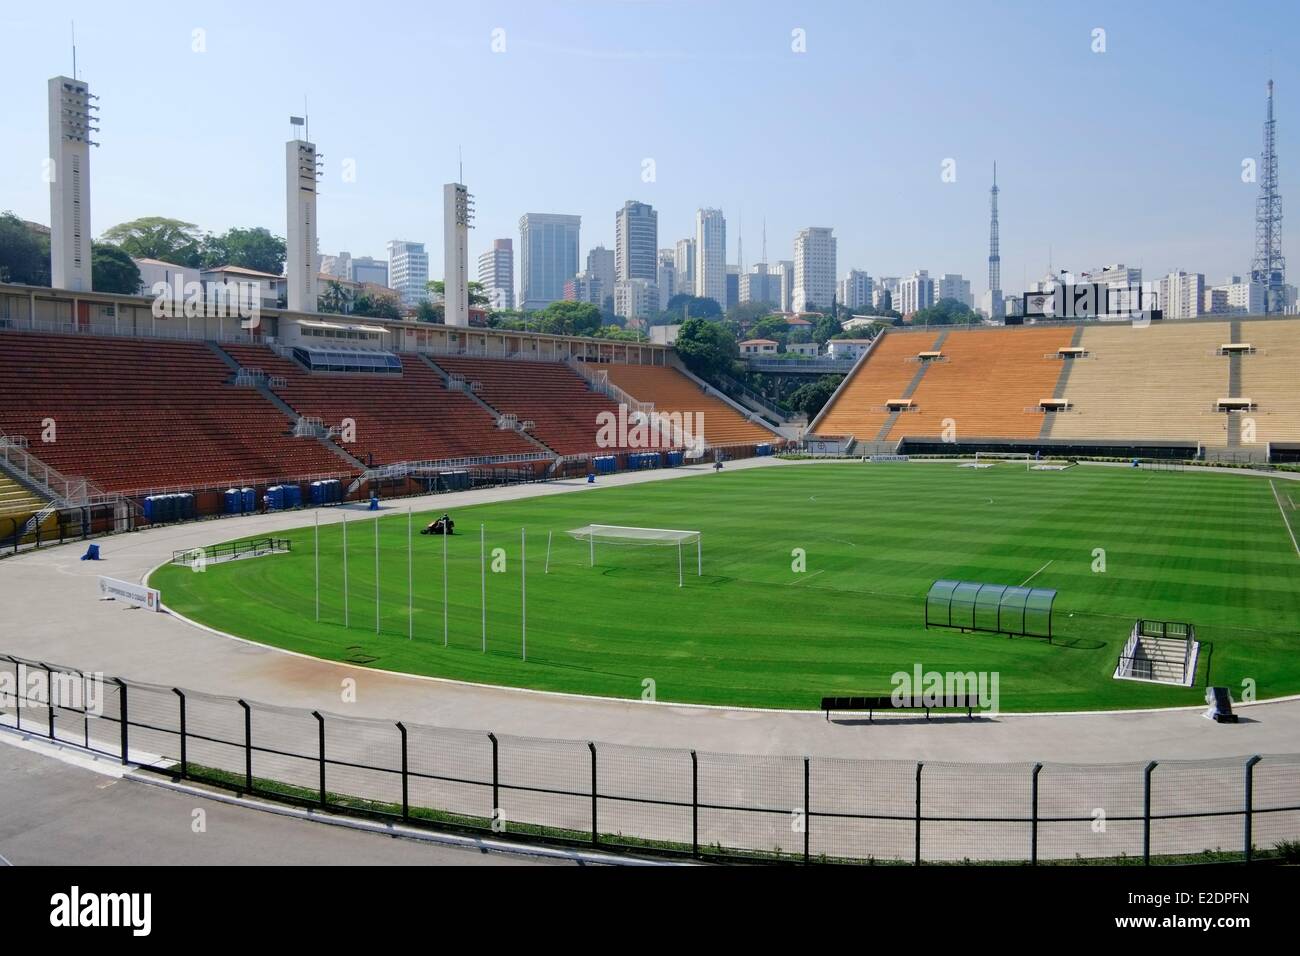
[47,77,99,293]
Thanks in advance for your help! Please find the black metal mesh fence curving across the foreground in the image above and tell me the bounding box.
[0,657,1300,864]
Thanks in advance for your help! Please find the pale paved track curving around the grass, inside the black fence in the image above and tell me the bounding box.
[0,459,1300,762]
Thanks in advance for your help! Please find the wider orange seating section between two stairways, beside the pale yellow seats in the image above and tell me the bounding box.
[868,326,1074,441]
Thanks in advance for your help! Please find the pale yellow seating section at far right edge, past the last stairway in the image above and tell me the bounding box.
[1242,320,1300,442]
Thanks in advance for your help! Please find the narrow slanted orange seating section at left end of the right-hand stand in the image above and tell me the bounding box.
[816,332,937,441]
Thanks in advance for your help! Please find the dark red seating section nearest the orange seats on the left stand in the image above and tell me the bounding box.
[434,356,619,455]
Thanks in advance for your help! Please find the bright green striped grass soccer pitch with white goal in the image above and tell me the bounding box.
[151,462,1300,711]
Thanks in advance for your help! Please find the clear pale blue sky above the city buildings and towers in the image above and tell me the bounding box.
[0,0,1300,294]
